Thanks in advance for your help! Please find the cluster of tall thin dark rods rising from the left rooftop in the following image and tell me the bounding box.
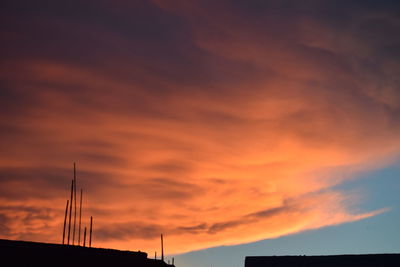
[62,163,93,247]
